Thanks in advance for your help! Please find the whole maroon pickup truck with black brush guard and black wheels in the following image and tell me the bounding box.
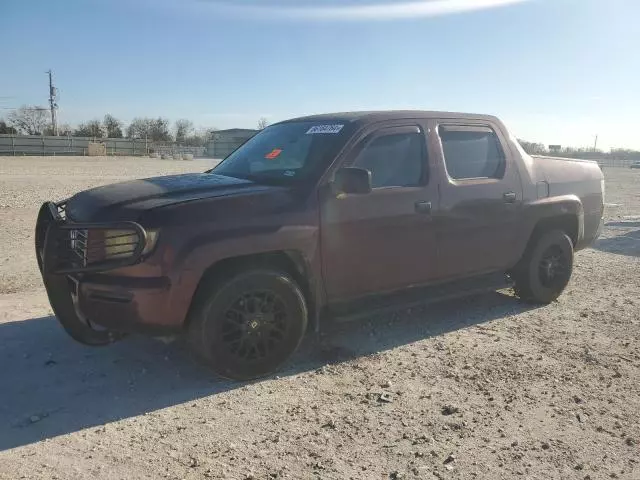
[35,111,604,379]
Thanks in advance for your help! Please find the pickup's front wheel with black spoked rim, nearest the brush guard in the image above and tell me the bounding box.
[188,269,308,380]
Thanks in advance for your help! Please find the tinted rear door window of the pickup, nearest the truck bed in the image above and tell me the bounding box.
[438,125,506,180]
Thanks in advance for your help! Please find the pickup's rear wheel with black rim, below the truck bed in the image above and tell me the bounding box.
[511,230,573,304]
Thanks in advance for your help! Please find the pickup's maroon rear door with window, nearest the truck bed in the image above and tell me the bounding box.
[431,120,522,278]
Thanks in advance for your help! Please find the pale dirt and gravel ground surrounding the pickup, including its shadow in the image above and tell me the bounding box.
[0,157,640,480]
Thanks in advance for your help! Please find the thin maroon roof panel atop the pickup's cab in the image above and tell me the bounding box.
[283,110,498,124]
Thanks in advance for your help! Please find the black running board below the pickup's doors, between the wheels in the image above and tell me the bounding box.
[328,273,513,322]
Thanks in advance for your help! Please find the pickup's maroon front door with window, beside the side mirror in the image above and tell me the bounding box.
[320,123,438,302]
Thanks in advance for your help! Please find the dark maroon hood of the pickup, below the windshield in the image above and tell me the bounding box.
[66,173,277,222]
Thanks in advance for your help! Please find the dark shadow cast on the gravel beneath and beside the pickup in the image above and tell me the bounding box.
[0,292,532,451]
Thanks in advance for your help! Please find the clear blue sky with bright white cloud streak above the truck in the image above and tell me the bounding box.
[0,0,640,149]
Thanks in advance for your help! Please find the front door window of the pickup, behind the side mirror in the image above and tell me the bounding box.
[353,128,426,188]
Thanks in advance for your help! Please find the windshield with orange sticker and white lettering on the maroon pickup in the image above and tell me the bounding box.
[212,121,349,183]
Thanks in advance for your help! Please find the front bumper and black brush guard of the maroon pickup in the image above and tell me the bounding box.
[35,202,184,345]
